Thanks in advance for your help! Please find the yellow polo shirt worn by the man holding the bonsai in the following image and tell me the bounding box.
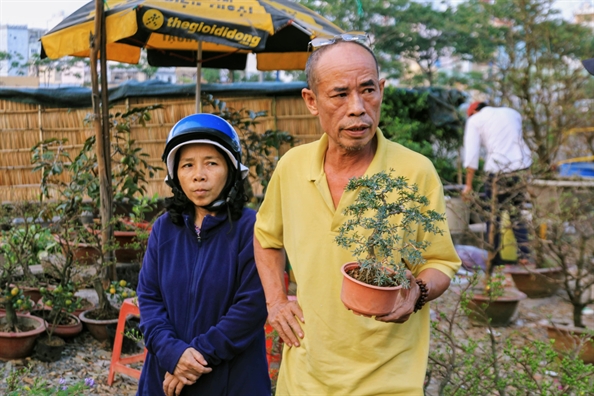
[255,129,460,396]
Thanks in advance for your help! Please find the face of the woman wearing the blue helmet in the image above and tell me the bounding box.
[177,143,229,207]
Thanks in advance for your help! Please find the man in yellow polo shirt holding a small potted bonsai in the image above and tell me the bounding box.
[254,35,460,396]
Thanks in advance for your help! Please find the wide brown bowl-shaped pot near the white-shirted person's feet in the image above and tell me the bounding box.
[508,266,563,298]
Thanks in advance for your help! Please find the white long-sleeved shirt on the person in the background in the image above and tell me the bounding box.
[464,106,532,173]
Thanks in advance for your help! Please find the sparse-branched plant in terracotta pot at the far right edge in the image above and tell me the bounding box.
[540,187,594,363]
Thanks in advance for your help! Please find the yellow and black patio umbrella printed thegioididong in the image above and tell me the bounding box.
[41,0,343,111]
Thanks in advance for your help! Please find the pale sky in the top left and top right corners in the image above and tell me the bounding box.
[0,0,594,30]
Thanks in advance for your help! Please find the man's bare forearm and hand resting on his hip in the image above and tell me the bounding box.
[254,237,305,346]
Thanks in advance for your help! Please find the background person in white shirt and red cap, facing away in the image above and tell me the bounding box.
[462,102,532,265]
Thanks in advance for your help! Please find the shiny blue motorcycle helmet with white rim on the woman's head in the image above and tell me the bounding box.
[162,113,249,210]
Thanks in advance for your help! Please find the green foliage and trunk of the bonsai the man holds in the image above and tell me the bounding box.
[335,169,445,287]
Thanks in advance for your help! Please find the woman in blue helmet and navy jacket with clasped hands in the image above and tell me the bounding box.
[138,114,270,396]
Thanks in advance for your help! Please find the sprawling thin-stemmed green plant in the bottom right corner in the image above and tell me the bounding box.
[425,274,594,396]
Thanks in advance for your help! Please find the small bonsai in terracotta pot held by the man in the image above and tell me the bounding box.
[335,170,445,316]
